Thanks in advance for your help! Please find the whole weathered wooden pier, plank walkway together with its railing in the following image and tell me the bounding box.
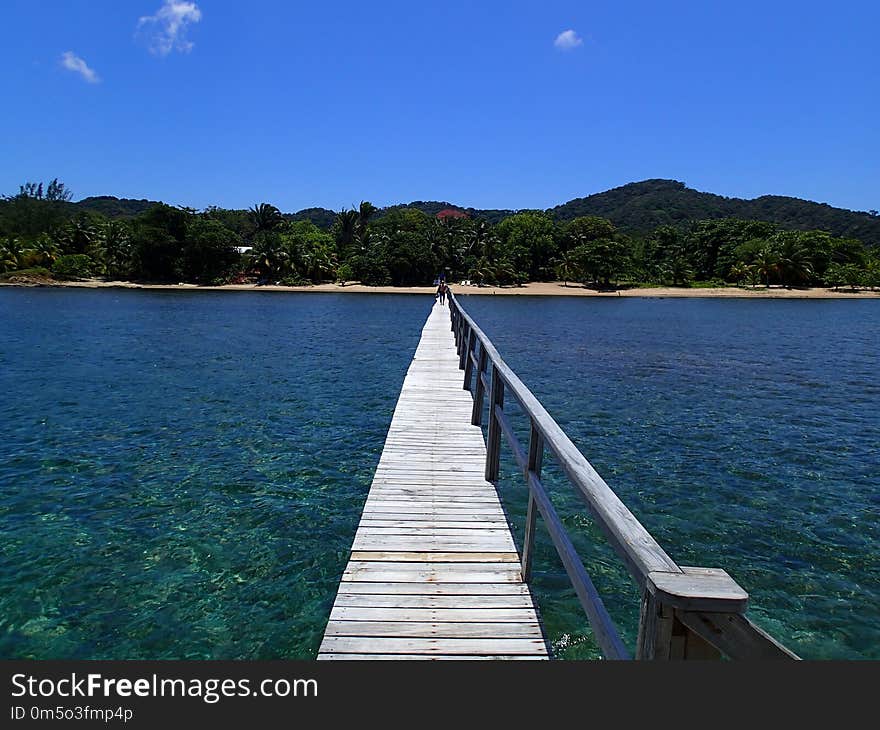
[318,294,797,660]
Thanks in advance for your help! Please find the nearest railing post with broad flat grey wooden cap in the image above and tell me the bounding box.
[636,566,749,660]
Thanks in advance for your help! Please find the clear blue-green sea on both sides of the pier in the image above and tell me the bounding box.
[0,288,880,659]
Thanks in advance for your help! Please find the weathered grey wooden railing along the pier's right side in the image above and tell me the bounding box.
[449,292,798,659]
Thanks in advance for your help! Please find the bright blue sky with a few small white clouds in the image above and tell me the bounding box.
[0,0,880,211]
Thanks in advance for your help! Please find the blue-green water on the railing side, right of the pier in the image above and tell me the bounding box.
[462,297,880,659]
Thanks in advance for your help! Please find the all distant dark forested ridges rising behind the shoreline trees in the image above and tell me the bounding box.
[75,179,880,246]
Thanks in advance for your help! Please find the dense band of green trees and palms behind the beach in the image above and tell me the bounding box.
[0,180,880,288]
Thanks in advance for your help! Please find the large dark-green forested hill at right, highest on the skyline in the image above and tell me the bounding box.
[548,180,880,245]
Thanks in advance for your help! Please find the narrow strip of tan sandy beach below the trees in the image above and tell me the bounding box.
[0,279,880,299]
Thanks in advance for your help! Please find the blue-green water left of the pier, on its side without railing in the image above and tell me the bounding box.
[0,290,431,658]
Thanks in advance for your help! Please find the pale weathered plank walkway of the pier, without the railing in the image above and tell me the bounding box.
[318,304,548,659]
